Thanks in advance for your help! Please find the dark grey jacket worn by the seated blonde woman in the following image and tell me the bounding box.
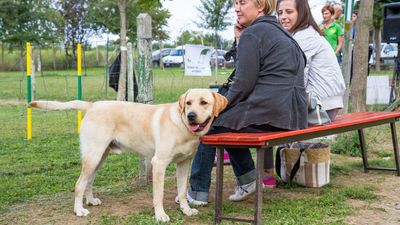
[213,16,307,130]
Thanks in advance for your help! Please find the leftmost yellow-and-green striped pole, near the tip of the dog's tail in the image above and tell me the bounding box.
[26,42,32,140]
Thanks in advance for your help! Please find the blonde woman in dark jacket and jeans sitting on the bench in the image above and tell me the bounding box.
[187,0,307,205]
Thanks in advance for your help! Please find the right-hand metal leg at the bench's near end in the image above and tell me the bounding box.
[254,148,269,225]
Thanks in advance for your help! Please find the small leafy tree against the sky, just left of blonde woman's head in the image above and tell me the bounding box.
[197,0,233,49]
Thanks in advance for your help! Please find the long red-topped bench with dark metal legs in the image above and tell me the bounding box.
[201,112,400,225]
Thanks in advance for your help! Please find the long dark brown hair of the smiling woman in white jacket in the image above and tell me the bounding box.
[276,0,324,36]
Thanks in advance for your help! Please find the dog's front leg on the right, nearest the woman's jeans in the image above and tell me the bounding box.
[176,158,199,216]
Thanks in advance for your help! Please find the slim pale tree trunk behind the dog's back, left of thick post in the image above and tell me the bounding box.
[117,0,127,101]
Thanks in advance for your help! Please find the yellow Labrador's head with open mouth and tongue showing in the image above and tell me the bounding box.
[179,89,228,136]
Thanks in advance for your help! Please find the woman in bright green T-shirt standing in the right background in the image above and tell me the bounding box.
[320,5,343,64]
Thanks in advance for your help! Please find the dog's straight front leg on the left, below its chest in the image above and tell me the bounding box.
[151,156,169,222]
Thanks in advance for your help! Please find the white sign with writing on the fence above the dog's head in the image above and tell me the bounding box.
[185,45,213,76]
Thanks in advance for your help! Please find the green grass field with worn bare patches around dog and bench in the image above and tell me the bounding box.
[0,68,400,224]
